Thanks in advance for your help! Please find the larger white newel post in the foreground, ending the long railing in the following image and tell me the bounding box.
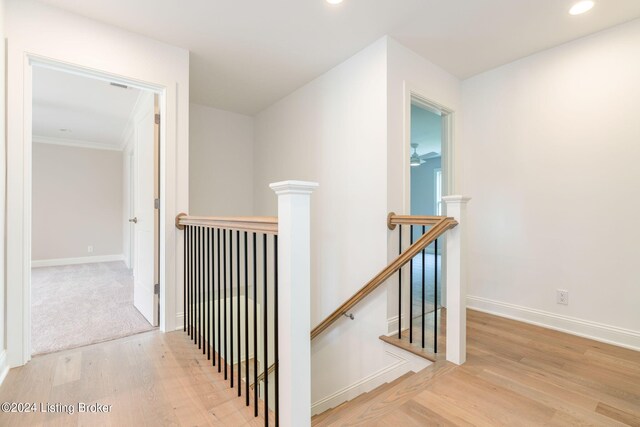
[269,181,318,427]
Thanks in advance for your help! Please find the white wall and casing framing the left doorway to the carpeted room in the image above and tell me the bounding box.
[6,0,189,366]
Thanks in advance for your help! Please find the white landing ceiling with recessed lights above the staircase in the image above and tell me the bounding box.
[40,0,640,114]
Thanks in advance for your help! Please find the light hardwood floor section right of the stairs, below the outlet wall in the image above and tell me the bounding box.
[313,310,640,427]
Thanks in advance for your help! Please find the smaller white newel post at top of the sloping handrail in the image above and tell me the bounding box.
[442,196,470,365]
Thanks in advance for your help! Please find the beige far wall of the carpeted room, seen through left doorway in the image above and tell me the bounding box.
[31,143,122,261]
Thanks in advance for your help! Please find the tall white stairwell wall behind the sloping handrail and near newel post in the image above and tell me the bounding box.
[254,39,393,412]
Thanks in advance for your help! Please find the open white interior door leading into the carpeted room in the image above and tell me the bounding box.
[133,97,159,326]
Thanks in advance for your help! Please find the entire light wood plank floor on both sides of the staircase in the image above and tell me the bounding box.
[0,310,640,427]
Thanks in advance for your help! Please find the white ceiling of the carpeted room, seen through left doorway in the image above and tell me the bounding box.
[33,66,141,149]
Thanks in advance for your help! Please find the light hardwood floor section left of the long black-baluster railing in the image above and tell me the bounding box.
[0,331,264,427]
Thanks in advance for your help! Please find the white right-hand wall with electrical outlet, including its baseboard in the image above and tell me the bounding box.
[459,20,640,348]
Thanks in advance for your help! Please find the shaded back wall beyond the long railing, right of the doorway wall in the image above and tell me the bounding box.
[189,103,254,216]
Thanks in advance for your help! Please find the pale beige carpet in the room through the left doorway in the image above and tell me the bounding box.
[31,262,153,354]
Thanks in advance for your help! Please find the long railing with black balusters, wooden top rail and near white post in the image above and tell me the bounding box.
[176,181,317,426]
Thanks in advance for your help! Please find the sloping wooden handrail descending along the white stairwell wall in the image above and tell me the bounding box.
[311,215,458,339]
